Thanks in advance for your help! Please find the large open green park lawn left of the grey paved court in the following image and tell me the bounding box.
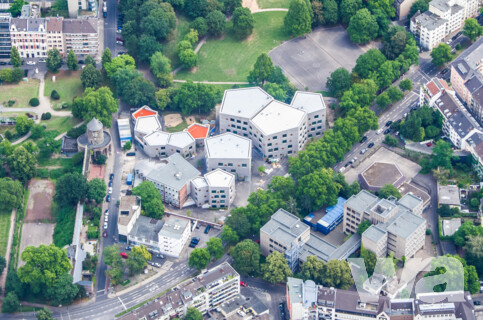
[175,12,289,81]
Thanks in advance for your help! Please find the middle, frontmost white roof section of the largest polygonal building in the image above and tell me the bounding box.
[252,100,306,135]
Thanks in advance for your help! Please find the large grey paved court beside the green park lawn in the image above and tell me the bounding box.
[268,26,364,91]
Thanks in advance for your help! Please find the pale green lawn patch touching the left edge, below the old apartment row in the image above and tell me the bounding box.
[0,79,40,108]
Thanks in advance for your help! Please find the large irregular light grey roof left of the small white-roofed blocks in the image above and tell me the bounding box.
[134,153,201,190]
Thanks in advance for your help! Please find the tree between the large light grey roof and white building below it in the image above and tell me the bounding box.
[132,181,164,219]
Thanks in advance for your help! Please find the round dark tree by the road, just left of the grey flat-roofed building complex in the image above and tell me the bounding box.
[230,240,260,275]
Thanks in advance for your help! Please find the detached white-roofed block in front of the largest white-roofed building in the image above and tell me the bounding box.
[205,132,252,181]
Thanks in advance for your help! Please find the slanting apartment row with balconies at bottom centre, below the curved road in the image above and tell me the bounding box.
[119,262,240,320]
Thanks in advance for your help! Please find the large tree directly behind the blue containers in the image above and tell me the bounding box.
[297,168,342,212]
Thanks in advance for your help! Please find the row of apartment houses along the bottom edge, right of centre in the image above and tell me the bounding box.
[286,278,476,320]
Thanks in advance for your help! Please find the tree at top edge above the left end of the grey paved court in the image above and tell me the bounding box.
[283,0,312,37]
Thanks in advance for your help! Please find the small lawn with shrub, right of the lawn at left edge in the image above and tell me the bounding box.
[44,70,84,109]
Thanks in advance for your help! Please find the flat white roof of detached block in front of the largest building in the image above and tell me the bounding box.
[205,132,252,159]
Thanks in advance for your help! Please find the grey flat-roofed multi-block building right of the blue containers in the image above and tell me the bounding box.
[344,190,426,258]
